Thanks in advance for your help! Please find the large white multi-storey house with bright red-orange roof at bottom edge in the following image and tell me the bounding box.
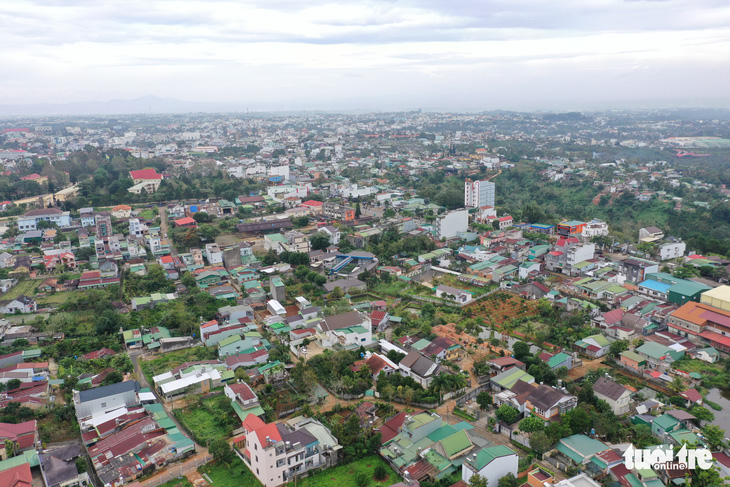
[236,414,342,487]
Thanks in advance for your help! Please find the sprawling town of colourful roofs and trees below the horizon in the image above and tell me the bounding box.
[0,110,730,487]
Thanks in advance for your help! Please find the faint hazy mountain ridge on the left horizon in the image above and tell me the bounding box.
[0,95,246,117]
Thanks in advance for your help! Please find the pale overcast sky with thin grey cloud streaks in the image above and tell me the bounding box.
[0,0,730,111]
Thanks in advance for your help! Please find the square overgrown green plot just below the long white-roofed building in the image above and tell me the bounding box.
[175,394,240,445]
